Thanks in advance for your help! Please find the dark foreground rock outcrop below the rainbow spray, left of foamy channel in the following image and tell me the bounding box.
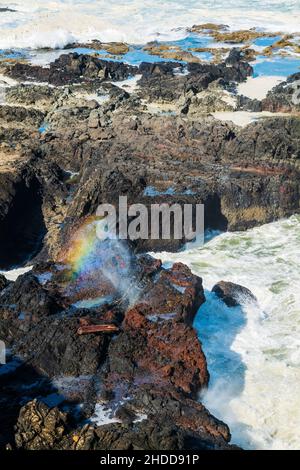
[0,252,231,450]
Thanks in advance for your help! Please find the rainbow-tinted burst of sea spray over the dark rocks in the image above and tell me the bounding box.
[61,216,139,303]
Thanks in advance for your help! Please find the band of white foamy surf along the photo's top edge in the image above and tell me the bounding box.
[0,0,300,49]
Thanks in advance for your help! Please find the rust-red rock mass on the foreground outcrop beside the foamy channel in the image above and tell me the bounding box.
[105,307,208,396]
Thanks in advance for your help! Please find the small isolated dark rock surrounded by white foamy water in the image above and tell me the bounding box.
[212,281,257,307]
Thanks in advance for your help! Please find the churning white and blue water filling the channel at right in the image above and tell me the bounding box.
[155,216,300,449]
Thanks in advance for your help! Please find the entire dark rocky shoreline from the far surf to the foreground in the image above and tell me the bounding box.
[0,45,300,450]
